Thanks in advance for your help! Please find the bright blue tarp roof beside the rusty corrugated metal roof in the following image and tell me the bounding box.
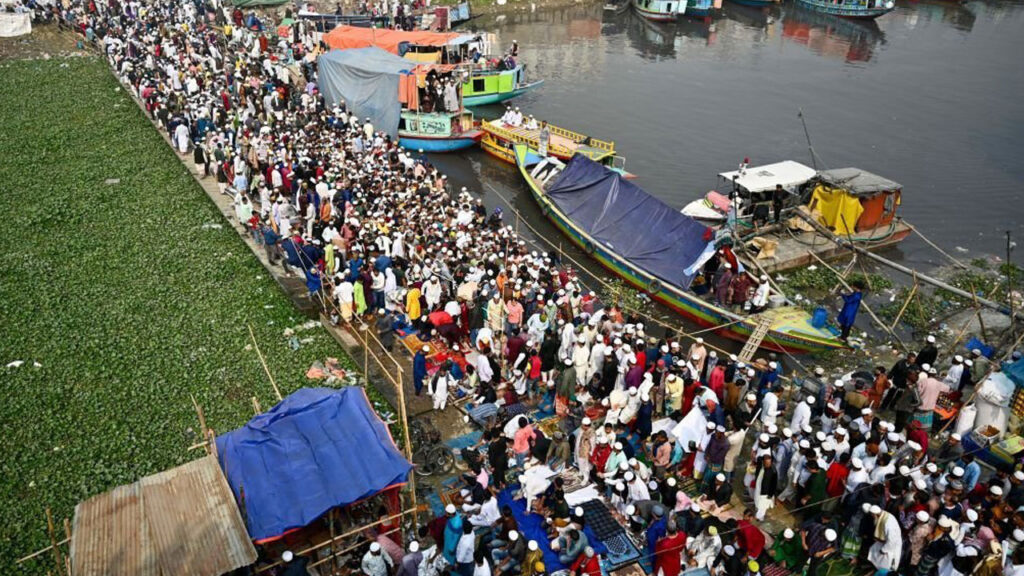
[217,386,413,541]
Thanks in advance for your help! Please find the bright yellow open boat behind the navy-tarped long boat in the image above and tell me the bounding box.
[480,118,634,178]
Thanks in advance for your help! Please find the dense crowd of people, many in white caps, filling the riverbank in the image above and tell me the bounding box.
[56,0,1024,576]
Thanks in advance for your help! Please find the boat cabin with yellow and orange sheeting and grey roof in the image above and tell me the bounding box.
[809,168,903,235]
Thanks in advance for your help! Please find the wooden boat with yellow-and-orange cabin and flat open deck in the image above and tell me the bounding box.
[740,168,912,272]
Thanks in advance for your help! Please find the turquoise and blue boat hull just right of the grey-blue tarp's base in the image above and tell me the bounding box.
[398,109,483,152]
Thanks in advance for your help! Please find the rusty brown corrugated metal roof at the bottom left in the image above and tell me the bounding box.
[71,456,256,576]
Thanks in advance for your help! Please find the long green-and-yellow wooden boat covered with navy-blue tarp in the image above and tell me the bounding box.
[513,145,846,353]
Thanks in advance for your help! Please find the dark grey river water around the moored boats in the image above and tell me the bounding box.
[432,0,1024,270]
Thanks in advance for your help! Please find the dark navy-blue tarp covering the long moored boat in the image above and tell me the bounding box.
[545,154,708,290]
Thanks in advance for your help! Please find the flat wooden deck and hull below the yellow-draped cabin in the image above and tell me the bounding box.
[740,220,910,273]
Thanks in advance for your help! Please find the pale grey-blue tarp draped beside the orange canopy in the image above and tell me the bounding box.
[316,46,416,137]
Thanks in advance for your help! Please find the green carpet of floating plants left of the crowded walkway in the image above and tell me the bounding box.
[0,57,379,574]
